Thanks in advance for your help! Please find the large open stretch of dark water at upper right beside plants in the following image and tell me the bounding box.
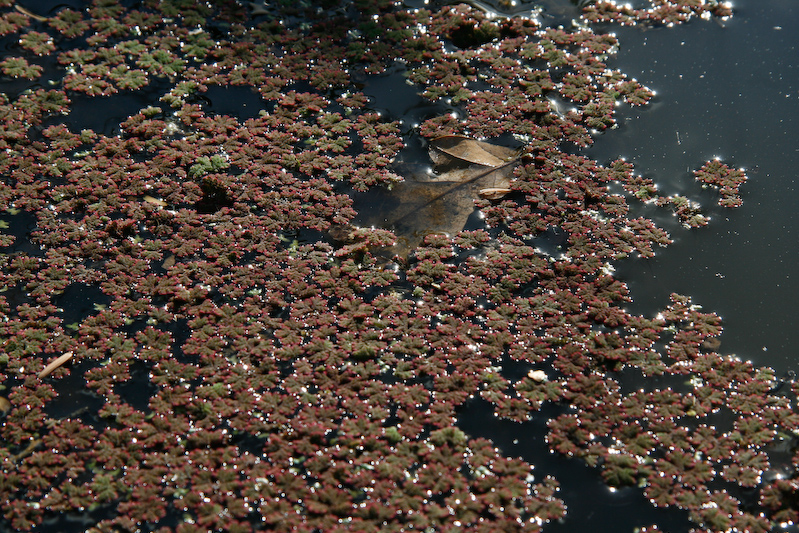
[585,0,799,374]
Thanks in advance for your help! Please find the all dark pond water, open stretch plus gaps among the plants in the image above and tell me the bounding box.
[3,0,799,532]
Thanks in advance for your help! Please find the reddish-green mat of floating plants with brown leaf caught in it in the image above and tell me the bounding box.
[0,0,799,532]
